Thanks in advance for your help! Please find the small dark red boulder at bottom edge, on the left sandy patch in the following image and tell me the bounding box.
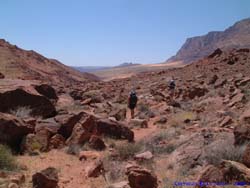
[32,167,59,188]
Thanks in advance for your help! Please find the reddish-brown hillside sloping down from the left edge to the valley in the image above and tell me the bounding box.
[0,39,98,83]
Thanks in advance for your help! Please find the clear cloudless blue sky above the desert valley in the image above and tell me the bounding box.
[0,0,250,66]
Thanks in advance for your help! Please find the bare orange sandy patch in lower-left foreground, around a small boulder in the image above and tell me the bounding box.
[18,150,92,188]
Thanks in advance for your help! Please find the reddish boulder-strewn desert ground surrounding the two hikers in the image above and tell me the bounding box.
[0,49,250,188]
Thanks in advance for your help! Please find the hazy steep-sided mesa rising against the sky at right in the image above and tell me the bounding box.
[167,18,250,63]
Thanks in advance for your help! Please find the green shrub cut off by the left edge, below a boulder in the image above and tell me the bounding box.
[0,145,17,171]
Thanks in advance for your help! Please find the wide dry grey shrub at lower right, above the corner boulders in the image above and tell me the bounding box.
[205,140,247,165]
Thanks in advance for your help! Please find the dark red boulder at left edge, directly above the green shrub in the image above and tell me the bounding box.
[0,113,34,149]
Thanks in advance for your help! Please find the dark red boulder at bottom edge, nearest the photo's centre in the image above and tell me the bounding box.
[126,165,158,188]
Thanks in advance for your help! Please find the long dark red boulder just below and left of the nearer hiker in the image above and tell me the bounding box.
[96,119,134,142]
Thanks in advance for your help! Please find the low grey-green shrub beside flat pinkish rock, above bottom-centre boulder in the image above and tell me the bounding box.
[115,142,143,160]
